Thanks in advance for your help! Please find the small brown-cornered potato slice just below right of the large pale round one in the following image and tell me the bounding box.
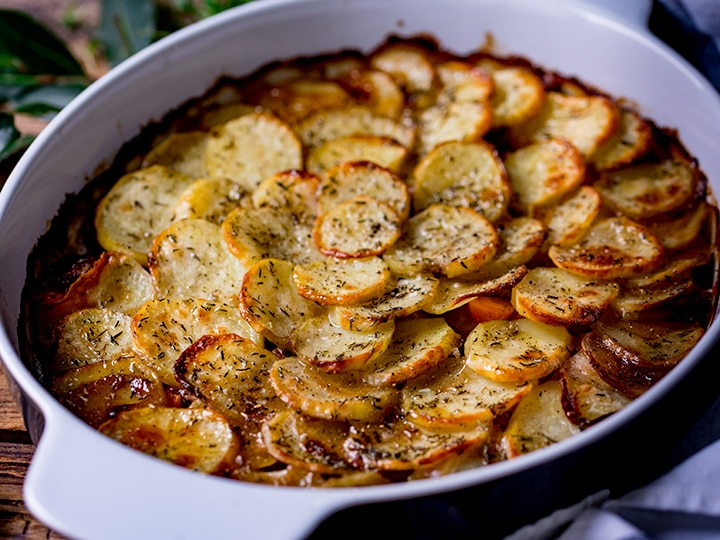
[252,170,320,217]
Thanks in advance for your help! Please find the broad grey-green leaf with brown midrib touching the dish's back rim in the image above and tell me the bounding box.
[99,0,155,65]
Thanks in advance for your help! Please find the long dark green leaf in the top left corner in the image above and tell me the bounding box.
[0,9,84,75]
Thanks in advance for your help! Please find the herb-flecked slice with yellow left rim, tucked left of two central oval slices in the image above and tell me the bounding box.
[240,259,320,347]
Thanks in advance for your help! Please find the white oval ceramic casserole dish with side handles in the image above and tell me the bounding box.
[0,0,720,538]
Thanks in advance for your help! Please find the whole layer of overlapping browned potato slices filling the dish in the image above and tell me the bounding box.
[23,38,717,487]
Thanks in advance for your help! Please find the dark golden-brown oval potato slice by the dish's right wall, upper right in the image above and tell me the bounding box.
[595,160,697,219]
